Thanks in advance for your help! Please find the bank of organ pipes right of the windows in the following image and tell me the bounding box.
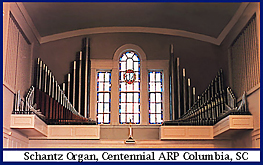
[167,45,250,125]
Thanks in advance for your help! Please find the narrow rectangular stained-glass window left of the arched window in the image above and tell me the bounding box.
[97,71,111,124]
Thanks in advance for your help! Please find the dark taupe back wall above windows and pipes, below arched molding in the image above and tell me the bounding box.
[38,33,228,95]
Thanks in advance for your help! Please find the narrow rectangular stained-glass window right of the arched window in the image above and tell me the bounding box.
[148,71,163,124]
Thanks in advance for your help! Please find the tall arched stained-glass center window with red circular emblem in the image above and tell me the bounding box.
[119,51,140,124]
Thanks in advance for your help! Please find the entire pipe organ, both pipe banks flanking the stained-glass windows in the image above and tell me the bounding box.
[13,38,250,125]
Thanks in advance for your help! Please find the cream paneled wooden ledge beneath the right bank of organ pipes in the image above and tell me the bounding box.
[160,115,253,140]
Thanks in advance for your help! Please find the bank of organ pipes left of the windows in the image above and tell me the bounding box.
[13,38,96,124]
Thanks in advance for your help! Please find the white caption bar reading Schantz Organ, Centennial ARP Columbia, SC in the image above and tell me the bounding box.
[3,150,260,162]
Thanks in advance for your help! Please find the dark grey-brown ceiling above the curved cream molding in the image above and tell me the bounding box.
[23,2,241,43]
